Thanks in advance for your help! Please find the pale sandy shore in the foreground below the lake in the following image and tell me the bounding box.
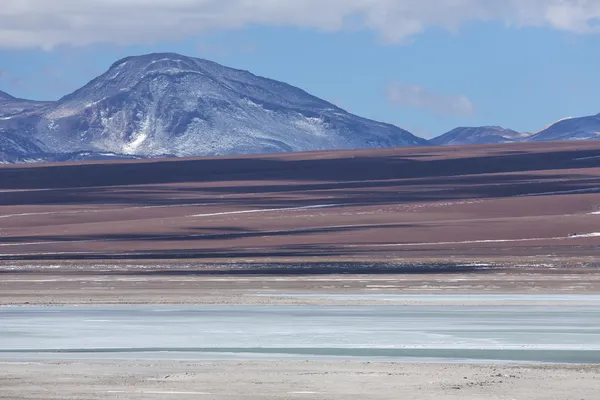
[0,360,600,400]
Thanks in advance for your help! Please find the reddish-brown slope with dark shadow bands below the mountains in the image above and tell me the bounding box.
[0,141,600,261]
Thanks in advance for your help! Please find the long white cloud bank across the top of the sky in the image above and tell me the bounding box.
[0,0,600,48]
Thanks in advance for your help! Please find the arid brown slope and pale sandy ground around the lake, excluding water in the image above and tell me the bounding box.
[0,142,600,400]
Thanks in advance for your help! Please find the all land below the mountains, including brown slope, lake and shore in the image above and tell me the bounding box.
[0,141,600,400]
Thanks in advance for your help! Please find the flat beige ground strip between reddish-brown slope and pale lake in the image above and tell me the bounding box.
[0,264,600,305]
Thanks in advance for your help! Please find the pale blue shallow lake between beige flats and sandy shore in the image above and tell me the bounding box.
[0,296,600,363]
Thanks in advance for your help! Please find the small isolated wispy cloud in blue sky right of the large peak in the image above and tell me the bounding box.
[387,82,475,117]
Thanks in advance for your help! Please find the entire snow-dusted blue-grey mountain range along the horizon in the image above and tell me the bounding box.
[0,53,600,163]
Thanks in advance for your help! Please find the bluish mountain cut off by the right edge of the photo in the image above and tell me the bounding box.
[528,114,600,142]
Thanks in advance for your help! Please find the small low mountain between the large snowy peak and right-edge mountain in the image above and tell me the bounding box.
[430,126,527,146]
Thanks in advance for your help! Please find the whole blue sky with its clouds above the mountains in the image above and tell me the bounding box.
[0,0,600,137]
